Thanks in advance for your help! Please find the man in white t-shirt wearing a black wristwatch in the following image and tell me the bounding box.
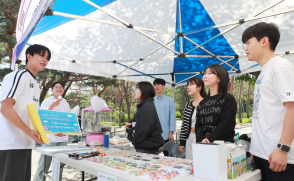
[242,22,294,181]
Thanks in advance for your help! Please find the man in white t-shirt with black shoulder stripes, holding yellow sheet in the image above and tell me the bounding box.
[0,45,51,181]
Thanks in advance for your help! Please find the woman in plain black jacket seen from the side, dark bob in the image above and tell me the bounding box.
[125,82,164,154]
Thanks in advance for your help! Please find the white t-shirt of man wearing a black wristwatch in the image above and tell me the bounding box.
[250,57,294,164]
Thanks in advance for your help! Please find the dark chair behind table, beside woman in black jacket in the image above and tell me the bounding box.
[162,140,185,158]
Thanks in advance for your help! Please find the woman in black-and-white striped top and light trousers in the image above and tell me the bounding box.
[180,77,207,160]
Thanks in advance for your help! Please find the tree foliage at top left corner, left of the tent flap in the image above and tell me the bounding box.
[0,0,21,63]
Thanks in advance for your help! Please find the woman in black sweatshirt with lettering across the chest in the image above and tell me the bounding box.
[195,65,237,143]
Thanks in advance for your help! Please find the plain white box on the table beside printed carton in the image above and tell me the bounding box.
[192,143,228,181]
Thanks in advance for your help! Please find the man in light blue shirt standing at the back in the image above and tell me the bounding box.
[153,78,176,146]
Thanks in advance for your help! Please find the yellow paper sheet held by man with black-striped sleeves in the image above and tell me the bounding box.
[27,103,50,145]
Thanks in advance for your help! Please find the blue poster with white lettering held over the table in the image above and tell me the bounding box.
[38,110,82,135]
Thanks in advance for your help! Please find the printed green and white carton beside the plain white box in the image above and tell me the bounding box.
[227,146,247,179]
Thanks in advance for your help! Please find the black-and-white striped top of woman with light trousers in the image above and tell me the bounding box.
[180,101,196,146]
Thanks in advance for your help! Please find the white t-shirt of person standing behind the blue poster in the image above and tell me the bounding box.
[40,96,70,143]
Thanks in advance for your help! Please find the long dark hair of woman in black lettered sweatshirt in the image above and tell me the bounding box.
[201,64,230,104]
